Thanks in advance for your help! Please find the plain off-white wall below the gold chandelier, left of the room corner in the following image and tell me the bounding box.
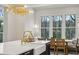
[3,8,34,42]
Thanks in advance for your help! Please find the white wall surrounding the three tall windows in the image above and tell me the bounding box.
[35,7,79,38]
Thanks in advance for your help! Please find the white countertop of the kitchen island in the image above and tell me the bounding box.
[3,40,49,55]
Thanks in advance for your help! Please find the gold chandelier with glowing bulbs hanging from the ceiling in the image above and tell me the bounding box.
[7,5,29,15]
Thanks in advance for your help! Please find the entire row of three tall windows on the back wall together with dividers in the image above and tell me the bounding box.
[41,14,76,40]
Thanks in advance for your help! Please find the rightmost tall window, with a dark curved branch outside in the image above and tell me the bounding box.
[65,14,76,39]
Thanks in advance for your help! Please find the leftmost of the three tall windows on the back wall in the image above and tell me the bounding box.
[41,16,49,39]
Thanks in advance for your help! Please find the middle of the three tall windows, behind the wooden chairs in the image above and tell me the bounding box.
[53,16,62,39]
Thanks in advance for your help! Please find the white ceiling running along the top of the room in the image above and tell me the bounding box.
[0,4,79,9]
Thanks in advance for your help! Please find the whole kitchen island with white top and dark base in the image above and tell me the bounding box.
[3,40,49,55]
